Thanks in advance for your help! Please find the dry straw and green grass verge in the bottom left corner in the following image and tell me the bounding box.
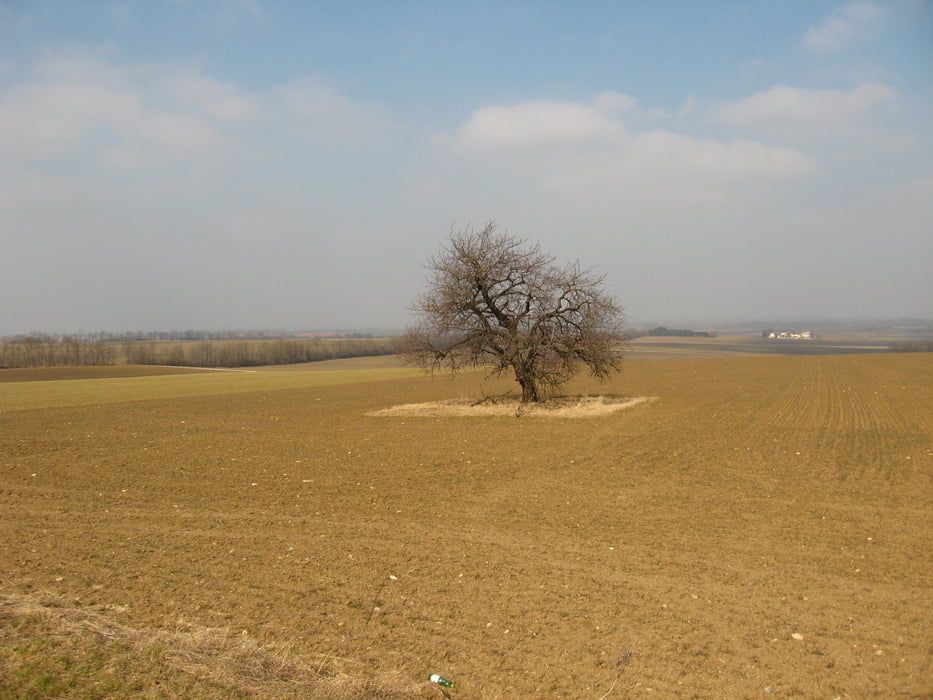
[0,595,415,700]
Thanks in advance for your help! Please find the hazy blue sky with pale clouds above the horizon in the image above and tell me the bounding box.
[0,0,933,335]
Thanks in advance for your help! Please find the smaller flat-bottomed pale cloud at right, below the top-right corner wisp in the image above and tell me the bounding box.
[712,83,899,141]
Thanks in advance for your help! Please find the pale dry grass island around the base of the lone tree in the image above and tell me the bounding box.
[366,396,657,418]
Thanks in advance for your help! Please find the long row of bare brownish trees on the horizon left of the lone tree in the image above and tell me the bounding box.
[0,334,398,369]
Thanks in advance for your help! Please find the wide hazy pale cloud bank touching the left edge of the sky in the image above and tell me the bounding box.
[0,52,387,177]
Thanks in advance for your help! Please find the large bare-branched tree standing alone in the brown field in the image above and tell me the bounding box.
[402,221,622,403]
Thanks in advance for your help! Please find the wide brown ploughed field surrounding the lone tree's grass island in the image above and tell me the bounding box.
[0,352,933,700]
